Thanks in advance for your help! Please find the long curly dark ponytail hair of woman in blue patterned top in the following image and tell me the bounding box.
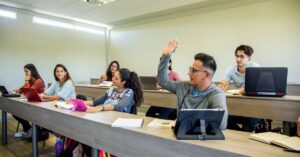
[118,68,144,106]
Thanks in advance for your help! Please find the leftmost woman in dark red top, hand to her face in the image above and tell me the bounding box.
[13,64,45,138]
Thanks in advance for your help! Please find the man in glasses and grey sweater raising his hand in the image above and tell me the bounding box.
[158,40,228,129]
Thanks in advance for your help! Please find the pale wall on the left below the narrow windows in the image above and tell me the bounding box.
[0,13,106,90]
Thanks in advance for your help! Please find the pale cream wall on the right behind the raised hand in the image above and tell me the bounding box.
[109,0,300,83]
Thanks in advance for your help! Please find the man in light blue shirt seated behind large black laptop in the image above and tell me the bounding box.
[218,45,260,132]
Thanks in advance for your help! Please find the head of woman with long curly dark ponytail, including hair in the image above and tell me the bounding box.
[113,68,144,106]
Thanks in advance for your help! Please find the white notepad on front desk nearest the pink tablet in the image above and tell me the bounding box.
[111,118,144,128]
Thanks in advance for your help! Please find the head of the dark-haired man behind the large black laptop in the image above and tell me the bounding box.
[234,45,253,67]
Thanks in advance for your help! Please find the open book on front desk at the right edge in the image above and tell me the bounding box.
[249,132,300,151]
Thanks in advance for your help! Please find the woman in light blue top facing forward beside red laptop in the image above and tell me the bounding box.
[41,64,76,101]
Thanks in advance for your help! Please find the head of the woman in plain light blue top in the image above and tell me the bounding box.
[53,64,71,83]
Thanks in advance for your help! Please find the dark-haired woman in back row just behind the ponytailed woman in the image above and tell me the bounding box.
[98,61,120,84]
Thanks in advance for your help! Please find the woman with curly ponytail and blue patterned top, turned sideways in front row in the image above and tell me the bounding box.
[86,68,144,113]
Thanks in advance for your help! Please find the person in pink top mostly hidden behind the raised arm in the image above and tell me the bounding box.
[146,59,181,120]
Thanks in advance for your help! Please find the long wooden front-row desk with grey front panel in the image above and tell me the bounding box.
[0,97,298,157]
